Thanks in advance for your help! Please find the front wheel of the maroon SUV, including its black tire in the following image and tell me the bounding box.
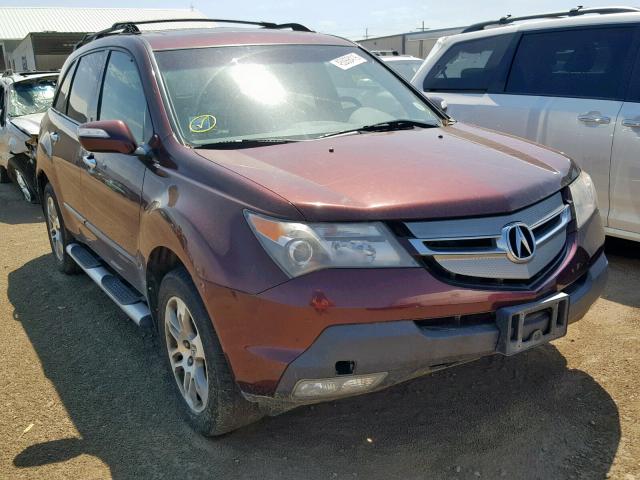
[158,268,263,436]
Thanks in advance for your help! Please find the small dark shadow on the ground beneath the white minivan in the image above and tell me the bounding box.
[602,237,640,308]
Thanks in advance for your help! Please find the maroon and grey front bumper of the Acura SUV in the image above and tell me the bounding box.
[198,210,606,404]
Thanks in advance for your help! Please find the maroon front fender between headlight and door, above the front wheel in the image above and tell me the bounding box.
[139,166,288,293]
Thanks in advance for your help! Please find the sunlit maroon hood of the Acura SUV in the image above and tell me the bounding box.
[198,124,577,221]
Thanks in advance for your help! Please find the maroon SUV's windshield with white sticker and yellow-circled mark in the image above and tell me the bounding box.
[156,45,440,146]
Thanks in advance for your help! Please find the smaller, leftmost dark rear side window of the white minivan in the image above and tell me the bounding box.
[424,35,513,90]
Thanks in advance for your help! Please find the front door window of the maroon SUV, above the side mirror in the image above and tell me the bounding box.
[99,52,149,143]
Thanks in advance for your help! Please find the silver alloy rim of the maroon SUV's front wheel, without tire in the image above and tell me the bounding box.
[164,297,209,413]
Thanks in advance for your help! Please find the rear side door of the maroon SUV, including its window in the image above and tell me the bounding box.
[40,50,106,226]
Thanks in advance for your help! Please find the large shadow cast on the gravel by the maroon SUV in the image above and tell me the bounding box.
[8,255,620,479]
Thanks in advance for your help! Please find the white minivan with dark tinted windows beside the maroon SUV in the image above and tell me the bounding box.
[413,7,640,240]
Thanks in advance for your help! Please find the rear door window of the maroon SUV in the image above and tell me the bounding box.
[67,52,106,123]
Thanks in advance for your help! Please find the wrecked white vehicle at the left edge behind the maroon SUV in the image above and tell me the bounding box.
[0,72,58,202]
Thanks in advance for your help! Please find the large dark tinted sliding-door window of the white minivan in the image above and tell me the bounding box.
[506,28,633,99]
